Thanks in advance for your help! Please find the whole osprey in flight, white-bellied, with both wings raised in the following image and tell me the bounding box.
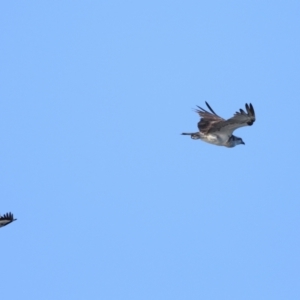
[182,102,255,148]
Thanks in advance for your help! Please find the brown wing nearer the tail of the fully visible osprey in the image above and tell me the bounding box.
[195,102,225,133]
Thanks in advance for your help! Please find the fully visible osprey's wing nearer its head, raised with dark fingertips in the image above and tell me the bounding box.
[209,103,255,136]
